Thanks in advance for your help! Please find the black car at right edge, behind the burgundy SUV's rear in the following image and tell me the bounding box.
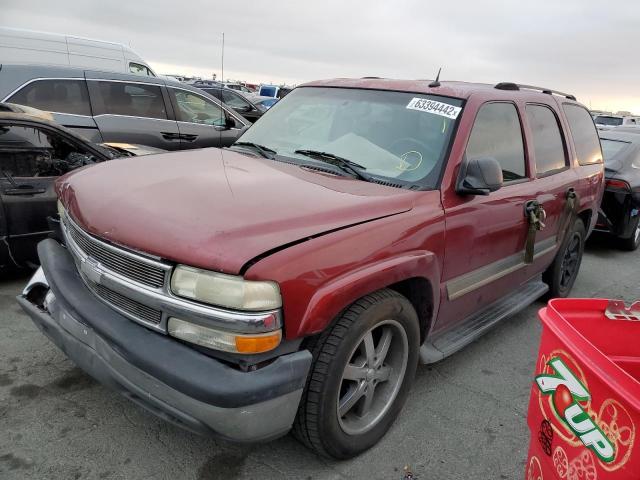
[596,130,640,250]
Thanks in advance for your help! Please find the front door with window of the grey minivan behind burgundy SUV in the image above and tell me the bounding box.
[168,87,246,148]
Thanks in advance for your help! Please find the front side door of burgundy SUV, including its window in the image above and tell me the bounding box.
[435,102,541,331]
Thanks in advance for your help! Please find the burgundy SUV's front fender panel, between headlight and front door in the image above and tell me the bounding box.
[244,187,444,339]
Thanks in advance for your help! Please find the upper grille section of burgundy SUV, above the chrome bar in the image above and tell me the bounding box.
[64,218,166,288]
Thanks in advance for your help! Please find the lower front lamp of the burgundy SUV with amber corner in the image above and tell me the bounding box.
[167,317,282,354]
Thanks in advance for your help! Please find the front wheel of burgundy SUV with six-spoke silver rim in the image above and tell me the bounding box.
[293,289,420,459]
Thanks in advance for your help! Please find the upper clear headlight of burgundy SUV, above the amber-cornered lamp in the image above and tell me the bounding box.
[171,265,282,311]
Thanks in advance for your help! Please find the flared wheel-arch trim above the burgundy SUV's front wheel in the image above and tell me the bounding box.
[292,251,440,337]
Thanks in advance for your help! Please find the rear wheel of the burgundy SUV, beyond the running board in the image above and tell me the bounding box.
[542,218,587,298]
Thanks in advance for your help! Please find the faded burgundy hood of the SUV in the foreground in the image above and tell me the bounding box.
[56,148,416,274]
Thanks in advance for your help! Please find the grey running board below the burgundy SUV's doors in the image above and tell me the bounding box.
[420,277,549,363]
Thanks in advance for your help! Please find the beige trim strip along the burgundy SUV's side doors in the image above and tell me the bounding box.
[446,235,557,300]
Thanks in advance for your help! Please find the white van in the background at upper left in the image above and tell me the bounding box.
[0,27,156,77]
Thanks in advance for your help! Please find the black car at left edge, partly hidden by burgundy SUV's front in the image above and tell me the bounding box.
[0,104,161,270]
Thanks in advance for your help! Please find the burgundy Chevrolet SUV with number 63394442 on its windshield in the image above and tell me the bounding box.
[18,78,603,458]
